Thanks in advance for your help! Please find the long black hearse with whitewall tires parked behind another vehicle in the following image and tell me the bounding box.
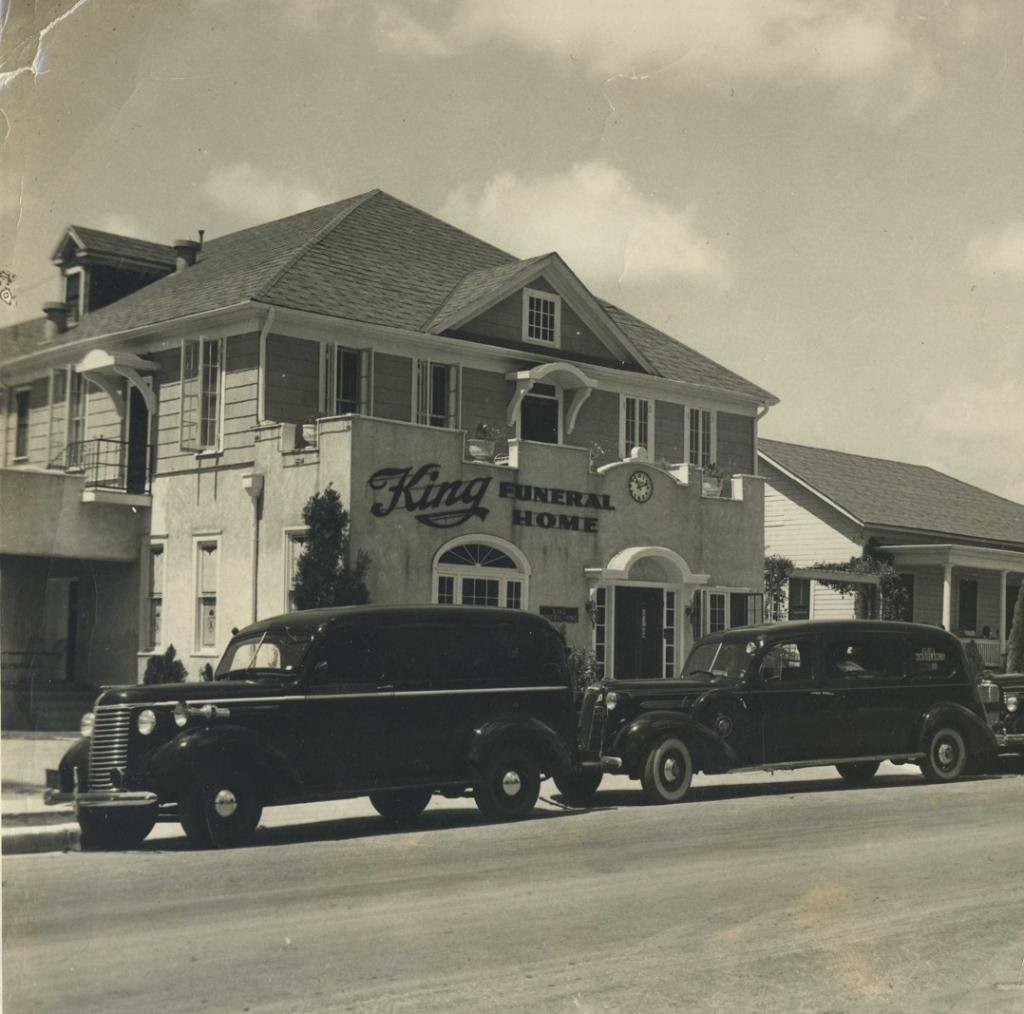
[580,621,995,803]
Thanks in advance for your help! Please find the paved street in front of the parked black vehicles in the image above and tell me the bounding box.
[3,765,1024,1014]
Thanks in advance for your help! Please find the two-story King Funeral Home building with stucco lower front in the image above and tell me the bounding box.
[0,191,776,722]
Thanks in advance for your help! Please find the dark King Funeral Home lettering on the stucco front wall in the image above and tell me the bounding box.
[369,463,615,534]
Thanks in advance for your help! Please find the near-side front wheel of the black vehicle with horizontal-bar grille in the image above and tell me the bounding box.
[178,765,263,848]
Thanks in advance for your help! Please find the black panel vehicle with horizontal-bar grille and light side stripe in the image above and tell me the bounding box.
[45,606,593,848]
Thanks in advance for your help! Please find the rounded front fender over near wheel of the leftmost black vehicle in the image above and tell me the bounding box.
[147,724,302,802]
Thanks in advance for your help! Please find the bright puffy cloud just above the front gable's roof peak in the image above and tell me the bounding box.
[440,160,729,288]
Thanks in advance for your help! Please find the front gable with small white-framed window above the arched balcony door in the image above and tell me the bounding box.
[428,253,654,373]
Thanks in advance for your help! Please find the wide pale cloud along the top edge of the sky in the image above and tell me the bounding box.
[382,0,948,122]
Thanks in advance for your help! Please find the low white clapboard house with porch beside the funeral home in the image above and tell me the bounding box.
[758,438,1024,665]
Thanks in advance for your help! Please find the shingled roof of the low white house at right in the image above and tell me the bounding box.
[758,437,1024,546]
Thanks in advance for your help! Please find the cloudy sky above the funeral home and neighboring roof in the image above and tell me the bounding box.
[0,0,1024,502]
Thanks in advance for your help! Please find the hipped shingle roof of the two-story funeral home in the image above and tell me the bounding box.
[5,191,778,404]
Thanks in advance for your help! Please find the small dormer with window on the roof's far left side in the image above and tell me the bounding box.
[52,225,179,328]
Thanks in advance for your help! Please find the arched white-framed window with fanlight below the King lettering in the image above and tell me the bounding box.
[434,537,529,609]
